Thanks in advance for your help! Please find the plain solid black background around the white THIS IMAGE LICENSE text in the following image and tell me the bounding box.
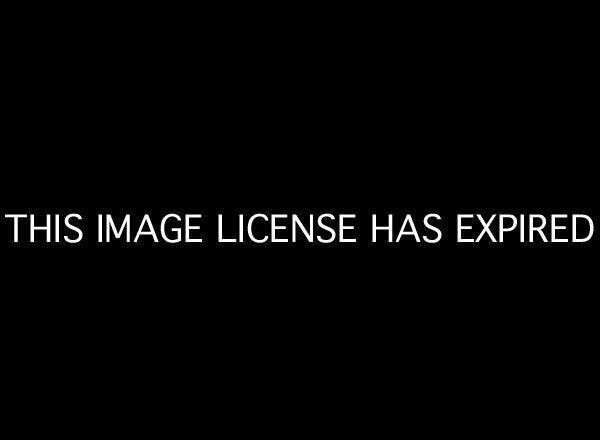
[1,5,598,433]
